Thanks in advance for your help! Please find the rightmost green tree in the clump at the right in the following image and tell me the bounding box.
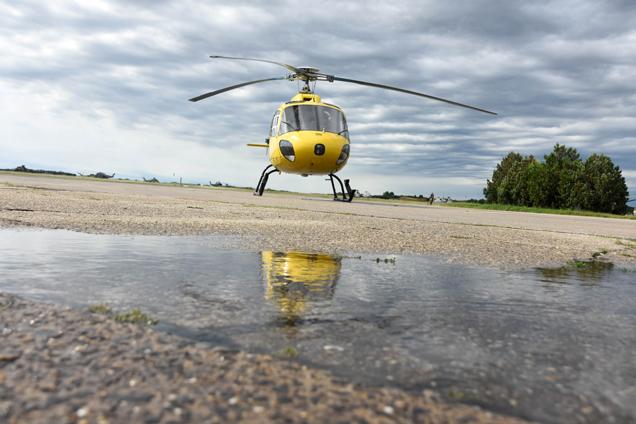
[584,154,629,213]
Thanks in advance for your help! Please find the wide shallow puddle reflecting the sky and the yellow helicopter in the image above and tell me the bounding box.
[0,230,636,422]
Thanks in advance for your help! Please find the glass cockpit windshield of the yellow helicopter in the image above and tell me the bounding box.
[280,105,348,136]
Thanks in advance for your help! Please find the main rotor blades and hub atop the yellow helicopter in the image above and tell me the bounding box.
[190,56,497,115]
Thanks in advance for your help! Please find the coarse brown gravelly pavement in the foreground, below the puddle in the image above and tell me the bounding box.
[0,294,521,423]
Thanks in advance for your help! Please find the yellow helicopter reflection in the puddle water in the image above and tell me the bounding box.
[261,251,341,326]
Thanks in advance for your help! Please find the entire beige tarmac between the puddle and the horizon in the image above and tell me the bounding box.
[0,173,636,269]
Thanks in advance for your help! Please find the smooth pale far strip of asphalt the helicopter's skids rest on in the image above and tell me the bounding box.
[0,173,636,239]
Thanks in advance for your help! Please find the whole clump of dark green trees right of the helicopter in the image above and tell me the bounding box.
[484,144,629,214]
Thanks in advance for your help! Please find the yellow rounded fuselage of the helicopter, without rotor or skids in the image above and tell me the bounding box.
[260,92,349,176]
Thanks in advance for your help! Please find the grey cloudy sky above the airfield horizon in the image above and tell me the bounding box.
[0,0,636,198]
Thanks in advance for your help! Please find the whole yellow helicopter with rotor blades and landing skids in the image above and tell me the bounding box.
[189,56,497,202]
